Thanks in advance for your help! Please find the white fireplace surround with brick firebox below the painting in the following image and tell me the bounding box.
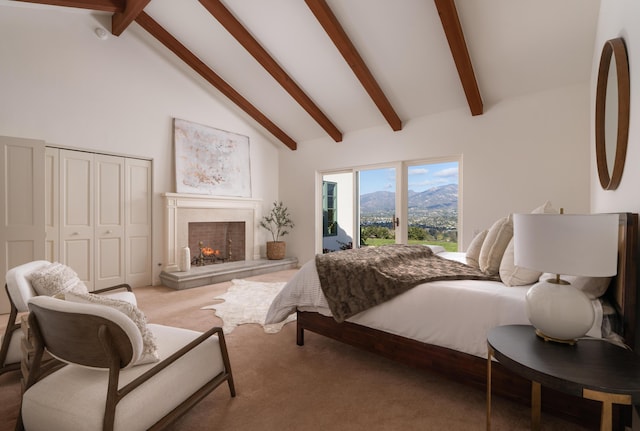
[164,193,262,272]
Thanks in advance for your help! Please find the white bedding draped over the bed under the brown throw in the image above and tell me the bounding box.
[266,252,602,358]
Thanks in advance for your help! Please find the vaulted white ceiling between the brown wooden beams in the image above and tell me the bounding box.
[7,0,600,147]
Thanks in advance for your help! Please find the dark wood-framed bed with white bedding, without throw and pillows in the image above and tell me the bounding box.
[269,213,638,426]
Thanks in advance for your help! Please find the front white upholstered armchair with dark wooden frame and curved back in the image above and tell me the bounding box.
[17,295,235,431]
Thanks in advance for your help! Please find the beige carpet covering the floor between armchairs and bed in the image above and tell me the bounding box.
[0,270,598,431]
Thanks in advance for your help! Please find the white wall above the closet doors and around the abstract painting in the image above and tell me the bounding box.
[0,5,288,283]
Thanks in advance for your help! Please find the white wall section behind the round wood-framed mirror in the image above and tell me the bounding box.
[590,0,640,212]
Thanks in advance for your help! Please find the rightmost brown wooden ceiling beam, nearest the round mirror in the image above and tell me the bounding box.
[434,0,483,115]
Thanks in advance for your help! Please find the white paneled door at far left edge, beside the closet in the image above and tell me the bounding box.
[0,136,45,313]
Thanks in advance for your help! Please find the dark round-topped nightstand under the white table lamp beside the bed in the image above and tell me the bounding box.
[487,325,640,430]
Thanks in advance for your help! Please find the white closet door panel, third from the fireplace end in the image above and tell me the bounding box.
[60,150,94,290]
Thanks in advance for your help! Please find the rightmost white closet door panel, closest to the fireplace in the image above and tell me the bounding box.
[125,159,152,286]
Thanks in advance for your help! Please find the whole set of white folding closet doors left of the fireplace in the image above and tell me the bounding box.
[53,148,152,290]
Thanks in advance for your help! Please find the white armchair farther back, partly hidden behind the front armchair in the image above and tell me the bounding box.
[0,260,136,374]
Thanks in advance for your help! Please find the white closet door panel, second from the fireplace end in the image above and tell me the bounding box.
[94,154,125,289]
